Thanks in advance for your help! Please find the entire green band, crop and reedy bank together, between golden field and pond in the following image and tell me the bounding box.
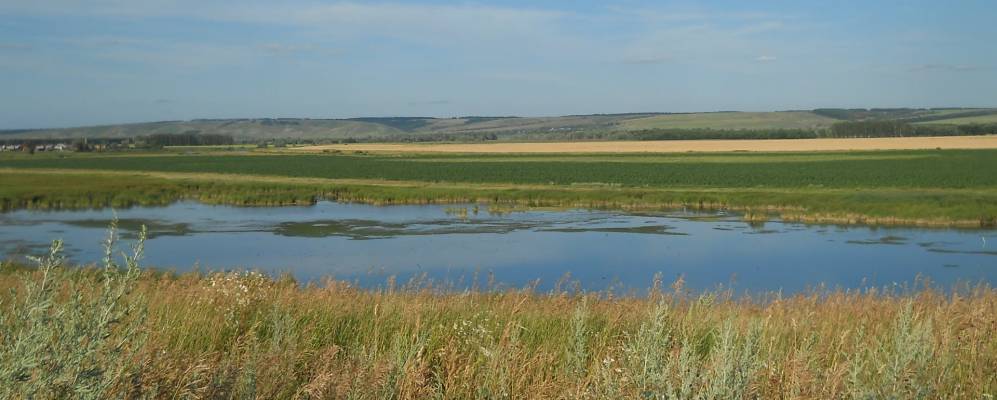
[0,150,997,227]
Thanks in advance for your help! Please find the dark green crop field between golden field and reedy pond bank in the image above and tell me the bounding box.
[0,150,997,189]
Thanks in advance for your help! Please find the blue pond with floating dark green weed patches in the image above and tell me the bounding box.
[0,203,997,292]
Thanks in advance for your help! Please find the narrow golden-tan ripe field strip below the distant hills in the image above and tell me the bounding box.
[289,135,997,153]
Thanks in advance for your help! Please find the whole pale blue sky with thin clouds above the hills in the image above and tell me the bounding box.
[0,0,997,129]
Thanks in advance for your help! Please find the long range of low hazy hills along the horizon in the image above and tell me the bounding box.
[0,108,997,142]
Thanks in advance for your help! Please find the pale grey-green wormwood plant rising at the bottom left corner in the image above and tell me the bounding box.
[0,220,146,399]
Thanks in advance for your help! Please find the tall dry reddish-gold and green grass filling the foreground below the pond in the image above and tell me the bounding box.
[0,231,997,399]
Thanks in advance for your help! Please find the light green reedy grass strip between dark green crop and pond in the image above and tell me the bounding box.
[0,168,997,228]
